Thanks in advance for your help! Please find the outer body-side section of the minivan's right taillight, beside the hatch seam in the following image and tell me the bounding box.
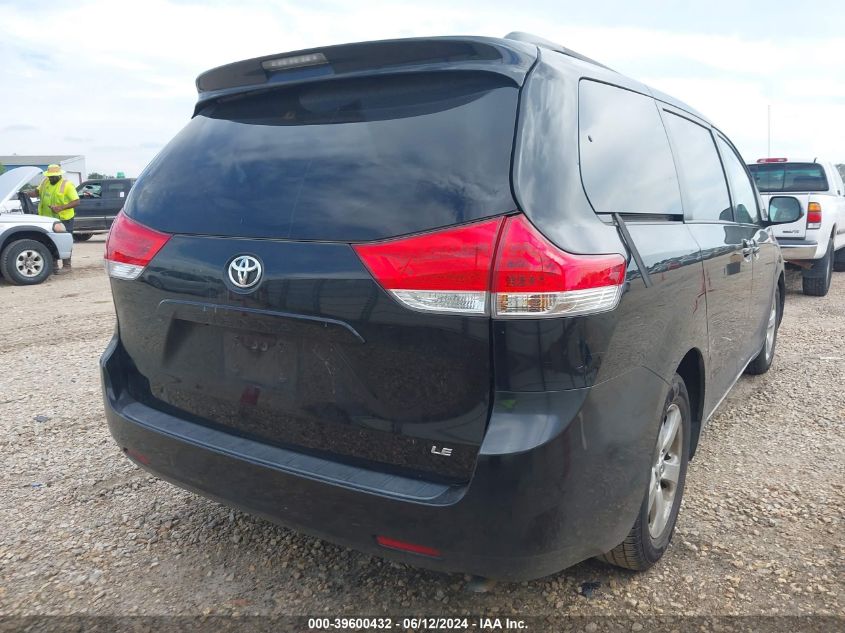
[492,215,625,317]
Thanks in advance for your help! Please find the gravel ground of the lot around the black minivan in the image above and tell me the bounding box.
[0,238,845,631]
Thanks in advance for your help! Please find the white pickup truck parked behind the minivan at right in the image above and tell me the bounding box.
[748,158,845,297]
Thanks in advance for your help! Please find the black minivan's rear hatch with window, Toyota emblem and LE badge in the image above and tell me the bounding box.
[112,72,518,481]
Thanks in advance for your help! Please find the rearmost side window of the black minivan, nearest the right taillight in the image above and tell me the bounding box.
[578,80,683,215]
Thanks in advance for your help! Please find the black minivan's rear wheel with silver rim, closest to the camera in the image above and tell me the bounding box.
[600,374,692,571]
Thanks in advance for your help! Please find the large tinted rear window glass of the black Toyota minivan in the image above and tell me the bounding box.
[127,73,518,241]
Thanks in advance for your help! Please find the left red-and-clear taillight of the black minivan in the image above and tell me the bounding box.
[105,211,170,279]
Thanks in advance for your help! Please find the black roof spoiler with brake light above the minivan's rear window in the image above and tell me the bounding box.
[194,37,537,114]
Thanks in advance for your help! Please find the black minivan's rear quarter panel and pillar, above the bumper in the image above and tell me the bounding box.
[508,51,707,391]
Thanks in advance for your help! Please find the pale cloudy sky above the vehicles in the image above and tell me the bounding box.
[0,0,845,176]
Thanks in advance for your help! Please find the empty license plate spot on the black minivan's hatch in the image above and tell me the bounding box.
[223,330,299,391]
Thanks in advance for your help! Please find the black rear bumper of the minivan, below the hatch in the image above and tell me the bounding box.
[101,339,666,580]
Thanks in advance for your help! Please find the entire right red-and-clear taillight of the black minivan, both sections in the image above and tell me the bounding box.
[354,215,625,318]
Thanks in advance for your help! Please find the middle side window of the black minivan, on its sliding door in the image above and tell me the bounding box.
[664,112,733,222]
